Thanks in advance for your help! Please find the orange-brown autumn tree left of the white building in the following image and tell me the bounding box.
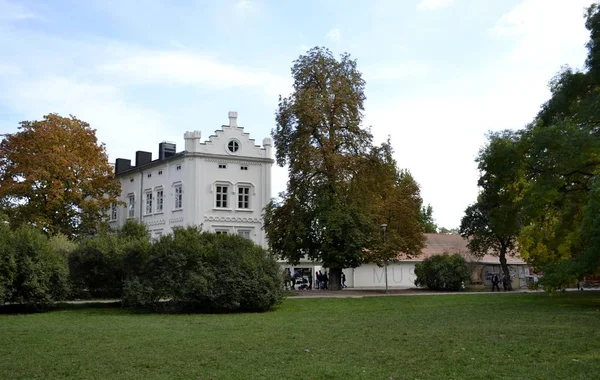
[0,113,120,237]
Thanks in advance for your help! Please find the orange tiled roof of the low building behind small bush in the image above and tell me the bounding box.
[397,234,526,264]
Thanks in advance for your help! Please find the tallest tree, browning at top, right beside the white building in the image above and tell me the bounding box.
[265,48,423,289]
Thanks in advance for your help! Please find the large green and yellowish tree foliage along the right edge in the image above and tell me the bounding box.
[510,4,600,276]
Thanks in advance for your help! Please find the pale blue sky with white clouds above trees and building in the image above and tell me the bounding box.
[0,0,591,228]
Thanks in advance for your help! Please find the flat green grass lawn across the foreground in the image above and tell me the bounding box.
[0,292,600,380]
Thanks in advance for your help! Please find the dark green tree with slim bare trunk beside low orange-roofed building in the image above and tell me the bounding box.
[460,130,525,290]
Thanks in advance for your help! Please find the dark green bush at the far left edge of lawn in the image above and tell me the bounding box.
[0,221,68,305]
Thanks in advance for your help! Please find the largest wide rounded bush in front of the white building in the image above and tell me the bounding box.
[123,227,283,312]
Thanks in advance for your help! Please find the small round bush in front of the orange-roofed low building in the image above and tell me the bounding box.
[415,253,471,290]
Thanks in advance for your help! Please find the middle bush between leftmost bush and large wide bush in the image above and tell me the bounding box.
[69,220,151,298]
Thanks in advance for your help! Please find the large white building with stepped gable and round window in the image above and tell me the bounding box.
[109,112,273,248]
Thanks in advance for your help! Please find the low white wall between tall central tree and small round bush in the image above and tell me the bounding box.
[346,262,417,288]
